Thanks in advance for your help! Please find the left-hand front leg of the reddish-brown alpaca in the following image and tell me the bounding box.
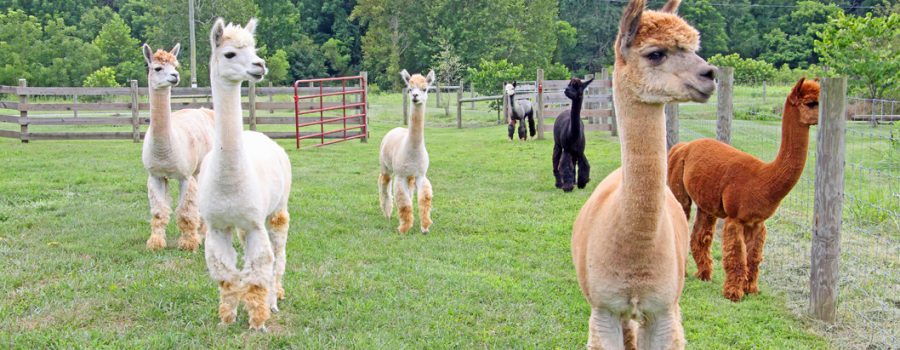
[722,218,747,302]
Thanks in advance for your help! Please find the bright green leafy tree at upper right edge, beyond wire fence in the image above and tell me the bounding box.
[815,13,900,98]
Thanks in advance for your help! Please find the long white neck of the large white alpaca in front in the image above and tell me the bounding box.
[210,77,244,154]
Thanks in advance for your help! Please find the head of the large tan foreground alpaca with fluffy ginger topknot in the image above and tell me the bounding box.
[615,0,716,104]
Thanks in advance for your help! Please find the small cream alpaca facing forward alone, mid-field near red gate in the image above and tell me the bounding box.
[378,69,434,234]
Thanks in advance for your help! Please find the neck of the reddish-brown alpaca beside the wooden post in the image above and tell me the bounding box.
[764,103,809,200]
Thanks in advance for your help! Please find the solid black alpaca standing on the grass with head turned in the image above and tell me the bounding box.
[553,78,594,192]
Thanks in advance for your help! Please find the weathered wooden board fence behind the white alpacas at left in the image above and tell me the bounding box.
[0,79,364,143]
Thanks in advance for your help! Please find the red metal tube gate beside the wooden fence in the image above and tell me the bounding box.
[294,75,369,148]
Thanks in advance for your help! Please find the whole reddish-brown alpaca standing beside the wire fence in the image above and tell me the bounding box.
[669,79,819,301]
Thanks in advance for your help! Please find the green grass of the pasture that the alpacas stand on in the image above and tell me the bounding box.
[0,97,828,349]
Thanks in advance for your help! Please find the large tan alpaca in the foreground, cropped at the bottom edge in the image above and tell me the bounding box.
[572,0,715,349]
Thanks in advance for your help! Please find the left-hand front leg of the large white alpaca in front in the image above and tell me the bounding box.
[204,229,244,324]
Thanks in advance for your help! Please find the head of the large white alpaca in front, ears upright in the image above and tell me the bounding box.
[209,18,268,85]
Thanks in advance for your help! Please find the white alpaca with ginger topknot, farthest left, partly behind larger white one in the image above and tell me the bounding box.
[141,44,215,251]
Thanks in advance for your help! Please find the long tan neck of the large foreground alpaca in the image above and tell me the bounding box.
[616,91,666,240]
